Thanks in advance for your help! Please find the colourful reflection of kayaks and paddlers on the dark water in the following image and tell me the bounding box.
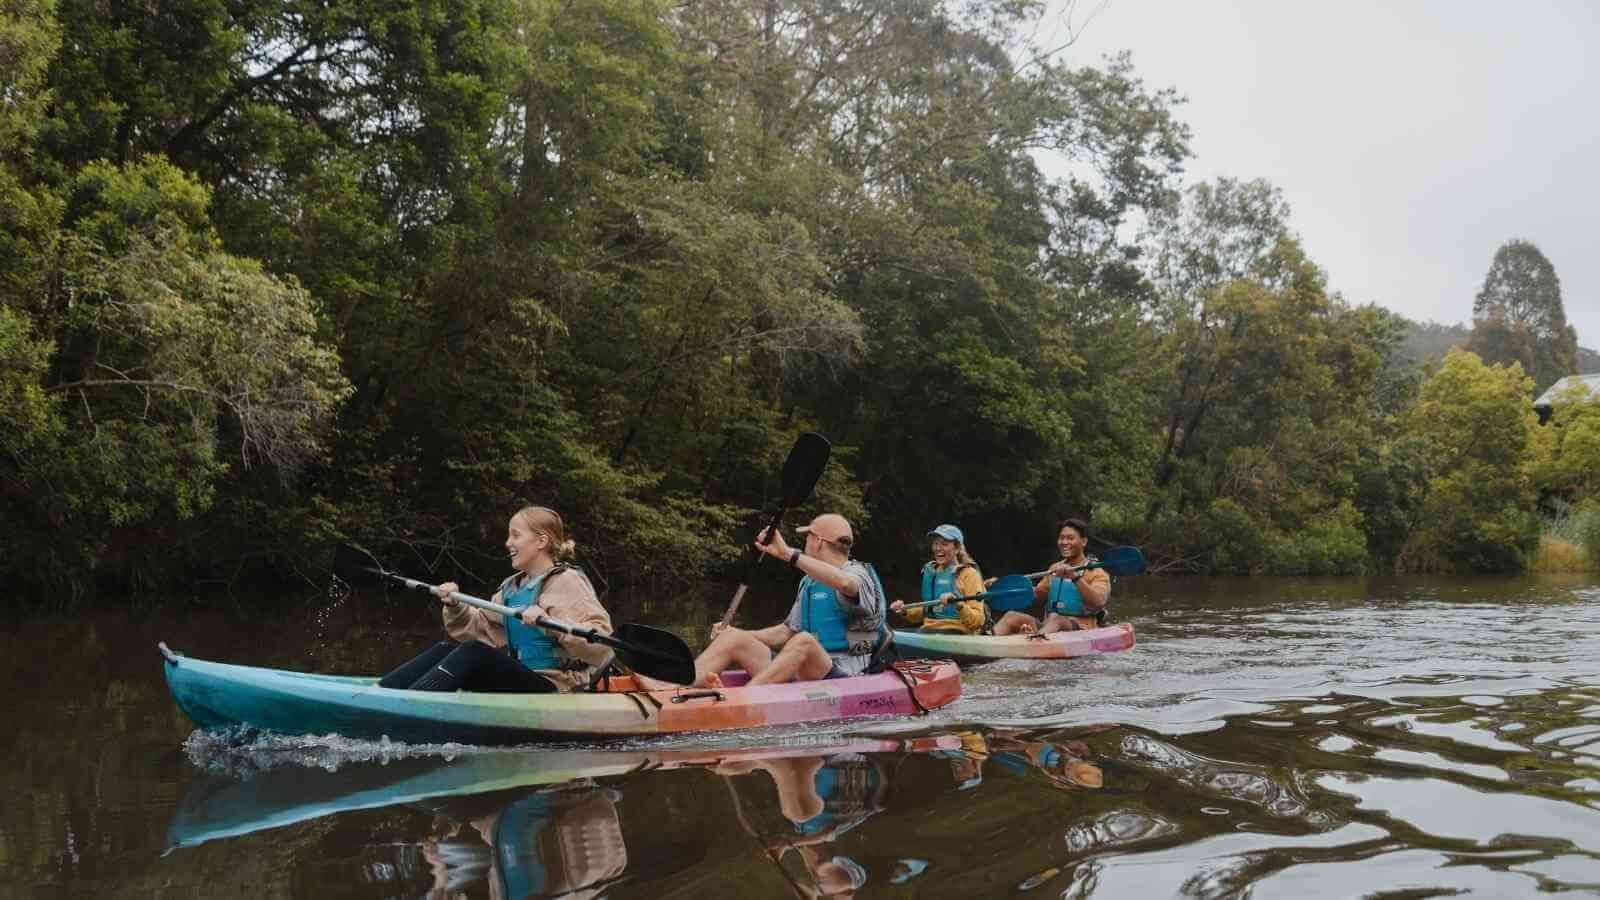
[170,729,1114,898]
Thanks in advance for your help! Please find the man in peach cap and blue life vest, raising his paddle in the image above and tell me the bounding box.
[646,512,888,687]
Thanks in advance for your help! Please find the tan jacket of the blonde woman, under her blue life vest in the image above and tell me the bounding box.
[445,569,611,690]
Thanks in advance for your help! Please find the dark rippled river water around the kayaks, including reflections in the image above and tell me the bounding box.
[0,577,1600,900]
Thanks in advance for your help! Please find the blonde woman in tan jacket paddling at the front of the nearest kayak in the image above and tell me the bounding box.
[379,506,611,693]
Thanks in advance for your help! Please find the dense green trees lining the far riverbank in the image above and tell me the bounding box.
[0,0,1600,602]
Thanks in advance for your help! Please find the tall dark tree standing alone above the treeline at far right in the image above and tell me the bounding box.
[1467,239,1578,394]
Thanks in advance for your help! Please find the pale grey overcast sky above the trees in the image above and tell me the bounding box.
[1051,0,1600,349]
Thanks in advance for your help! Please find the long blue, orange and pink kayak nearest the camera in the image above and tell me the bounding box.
[162,645,962,743]
